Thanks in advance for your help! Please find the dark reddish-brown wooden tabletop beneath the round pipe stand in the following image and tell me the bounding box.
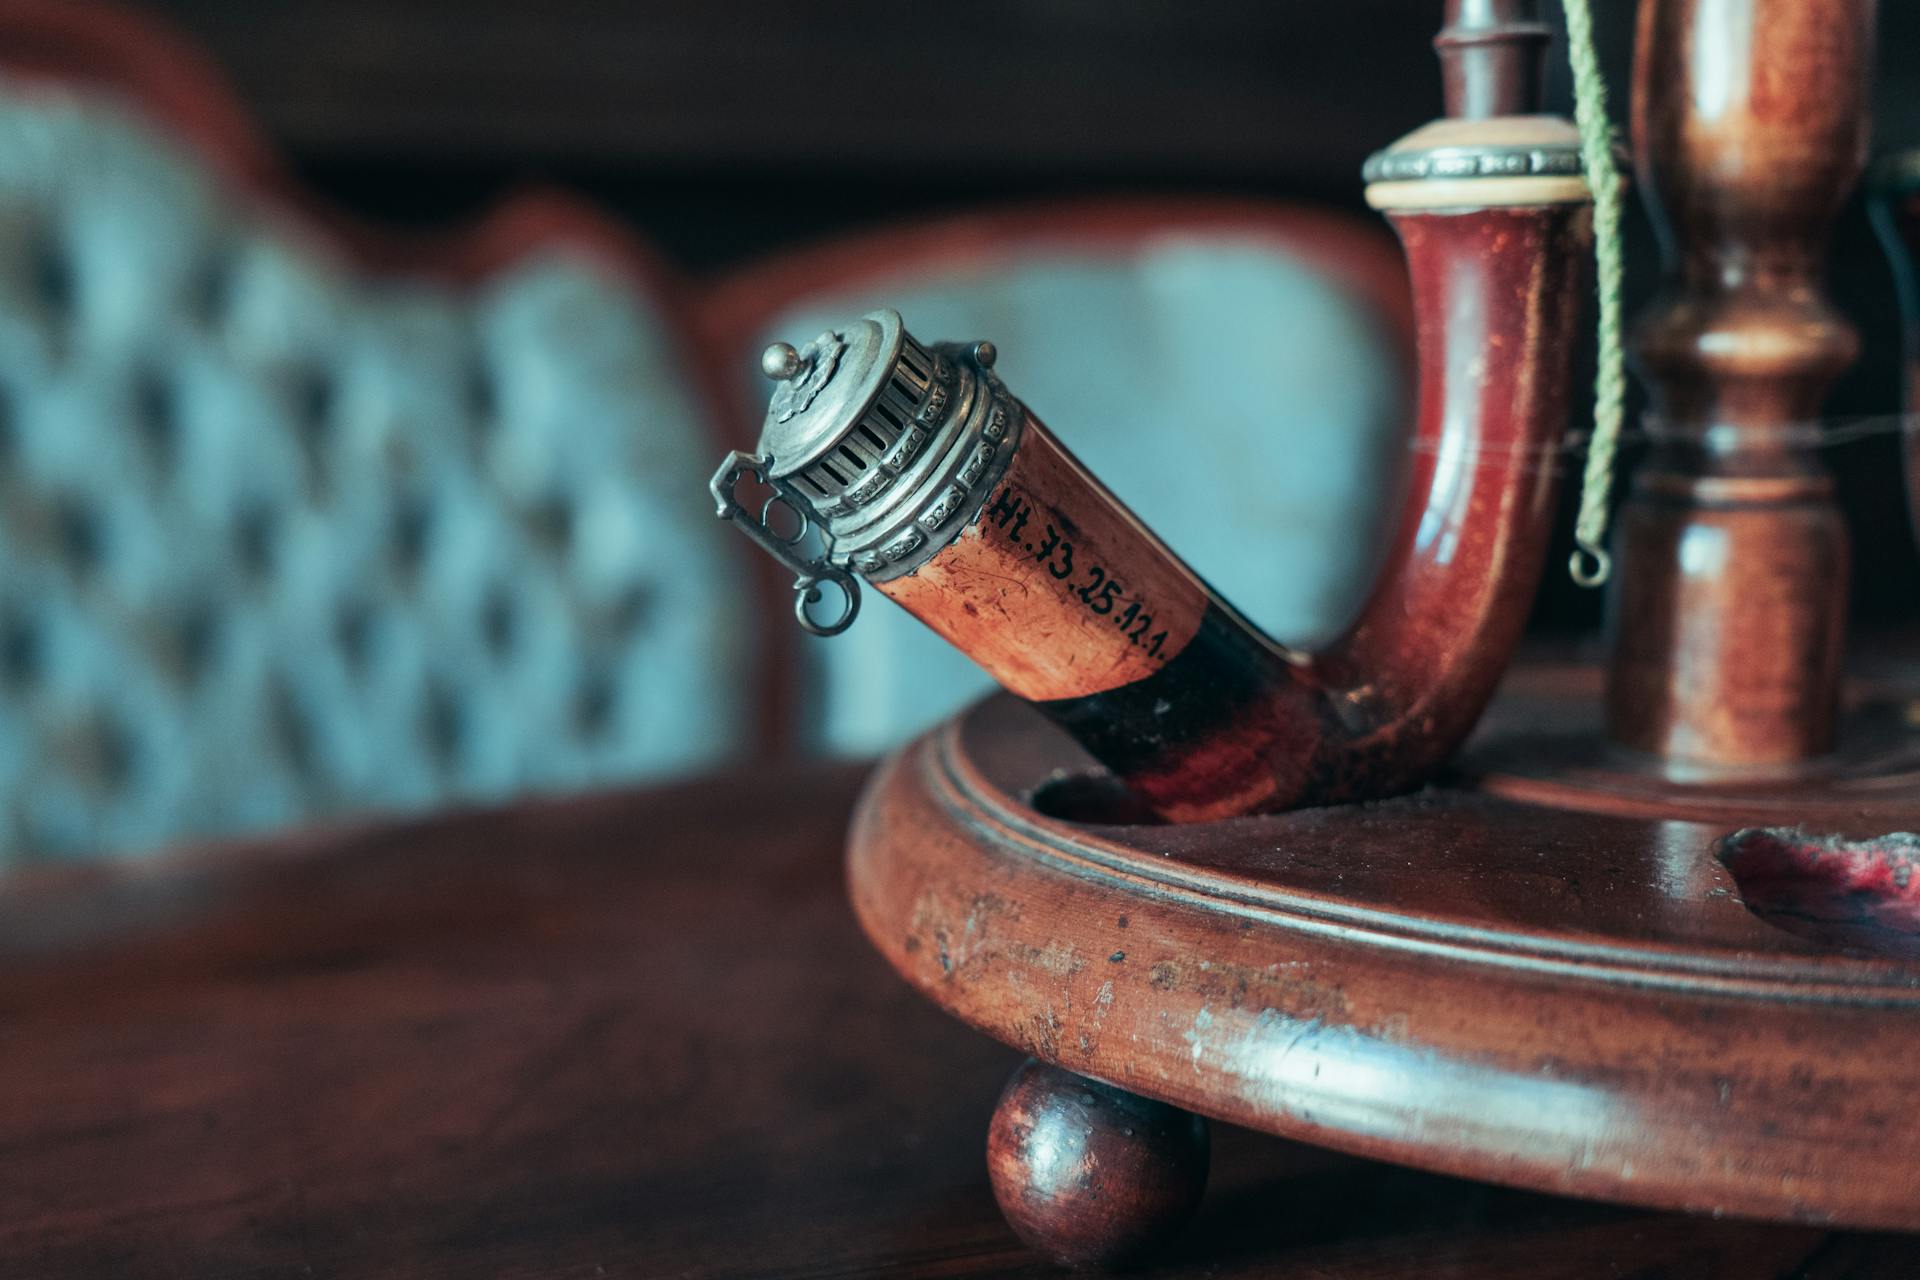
[0,768,1920,1280]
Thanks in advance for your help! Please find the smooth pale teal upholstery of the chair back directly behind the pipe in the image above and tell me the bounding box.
[743,245,1407,754]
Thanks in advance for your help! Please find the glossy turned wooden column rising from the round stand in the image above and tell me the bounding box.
[1607,0,1874,773]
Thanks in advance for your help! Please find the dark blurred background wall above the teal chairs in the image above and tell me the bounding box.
[148,0,1920,629]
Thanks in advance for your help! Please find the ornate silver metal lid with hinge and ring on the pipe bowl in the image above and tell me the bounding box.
[710,311,1021,635]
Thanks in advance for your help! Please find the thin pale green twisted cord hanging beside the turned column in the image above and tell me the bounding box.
[1565,0,1626,587]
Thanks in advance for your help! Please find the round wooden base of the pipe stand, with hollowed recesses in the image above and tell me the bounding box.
[849,670,1920,1258]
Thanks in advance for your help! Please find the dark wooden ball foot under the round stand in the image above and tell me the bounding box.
[987,1057,1208,1267]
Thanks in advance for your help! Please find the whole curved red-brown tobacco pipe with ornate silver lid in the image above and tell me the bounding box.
[712,0,1590,821]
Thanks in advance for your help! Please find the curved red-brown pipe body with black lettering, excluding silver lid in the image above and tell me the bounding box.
[877,189,1590,821]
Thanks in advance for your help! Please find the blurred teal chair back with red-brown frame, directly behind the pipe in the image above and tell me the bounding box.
[712,200,1411,754]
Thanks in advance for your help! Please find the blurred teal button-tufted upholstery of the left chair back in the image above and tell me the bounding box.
[0,81,753,865]
